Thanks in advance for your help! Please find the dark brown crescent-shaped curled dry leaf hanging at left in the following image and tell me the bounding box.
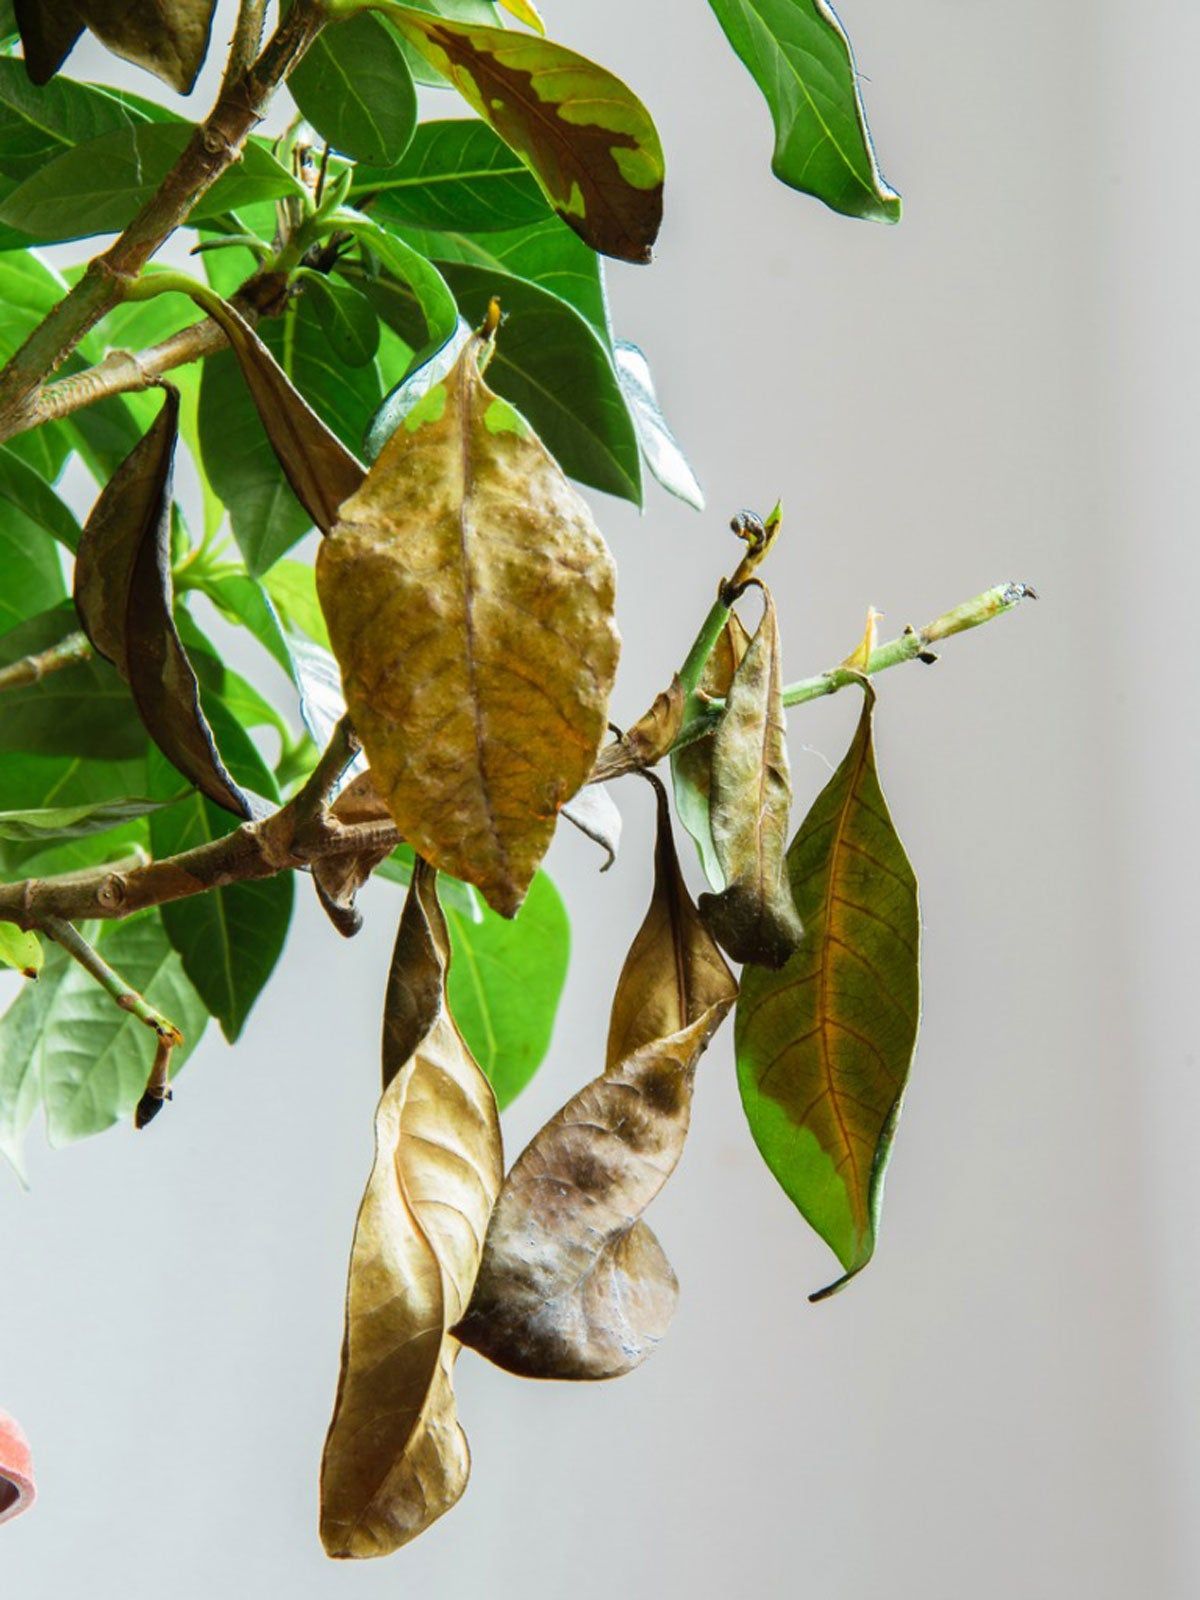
[75,386,253,816]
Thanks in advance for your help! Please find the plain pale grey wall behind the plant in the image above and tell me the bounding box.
[0,0,1200,1600]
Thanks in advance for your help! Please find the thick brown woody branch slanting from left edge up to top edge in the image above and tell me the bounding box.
[0,0,325,440]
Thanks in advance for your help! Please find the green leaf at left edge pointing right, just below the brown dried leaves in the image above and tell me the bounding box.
[0,58,178,181]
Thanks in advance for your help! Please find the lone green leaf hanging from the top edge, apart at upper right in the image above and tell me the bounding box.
[710,0,901,222]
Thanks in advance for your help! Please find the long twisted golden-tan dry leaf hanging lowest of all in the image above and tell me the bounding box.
[320,862,502,1557]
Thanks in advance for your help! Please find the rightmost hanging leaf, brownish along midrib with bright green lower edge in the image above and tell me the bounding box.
[734,694,920,1299]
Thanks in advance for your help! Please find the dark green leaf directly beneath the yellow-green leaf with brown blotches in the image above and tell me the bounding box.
[350,118,550,234]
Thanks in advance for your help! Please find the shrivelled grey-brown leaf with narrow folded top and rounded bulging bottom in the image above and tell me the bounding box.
[456,784,738,1379]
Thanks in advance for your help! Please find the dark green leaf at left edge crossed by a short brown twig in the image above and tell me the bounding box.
[0,605,146,762]
